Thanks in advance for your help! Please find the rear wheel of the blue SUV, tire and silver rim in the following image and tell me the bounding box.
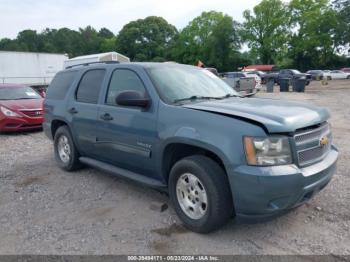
[54,126,82,171]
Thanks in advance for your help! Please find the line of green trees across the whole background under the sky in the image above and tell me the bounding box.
[0,4,350,71]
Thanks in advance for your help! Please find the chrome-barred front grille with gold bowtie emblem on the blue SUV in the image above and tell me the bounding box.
[294,123,332,166]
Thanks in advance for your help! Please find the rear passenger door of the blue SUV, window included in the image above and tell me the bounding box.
[67,69,106,156]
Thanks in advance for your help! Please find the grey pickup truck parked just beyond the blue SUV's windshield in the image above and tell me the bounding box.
[221,72,261,96]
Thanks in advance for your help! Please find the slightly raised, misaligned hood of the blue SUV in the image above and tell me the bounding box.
[184,98,329,133]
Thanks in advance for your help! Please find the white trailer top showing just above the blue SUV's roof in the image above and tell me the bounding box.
[64,52,130,68]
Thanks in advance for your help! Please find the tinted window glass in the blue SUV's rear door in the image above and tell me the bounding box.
[77,69,105,104]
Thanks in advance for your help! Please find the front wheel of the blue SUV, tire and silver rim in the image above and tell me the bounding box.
[169,155,234,233]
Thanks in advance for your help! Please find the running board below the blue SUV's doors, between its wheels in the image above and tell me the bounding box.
[79,157,167,190]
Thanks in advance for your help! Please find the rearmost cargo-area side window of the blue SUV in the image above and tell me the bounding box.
[46,71,76,100]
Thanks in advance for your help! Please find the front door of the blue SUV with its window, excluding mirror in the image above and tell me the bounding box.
[96,68,157,177]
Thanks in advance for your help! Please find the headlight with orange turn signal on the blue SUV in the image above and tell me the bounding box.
[244,136,292,166]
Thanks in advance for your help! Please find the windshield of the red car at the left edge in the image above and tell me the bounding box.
[0,86,42,100]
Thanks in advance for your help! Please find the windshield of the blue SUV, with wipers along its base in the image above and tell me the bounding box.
[147,66,240,103]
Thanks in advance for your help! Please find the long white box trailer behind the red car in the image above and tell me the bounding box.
[0,51,68,86]
